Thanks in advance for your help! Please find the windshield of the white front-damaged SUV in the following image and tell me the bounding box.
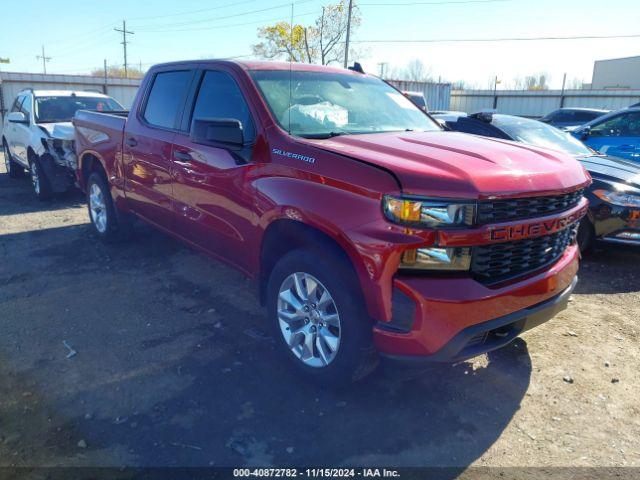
[34,95,124,123]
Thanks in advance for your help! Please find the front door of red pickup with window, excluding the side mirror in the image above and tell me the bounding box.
[172,70,256,270]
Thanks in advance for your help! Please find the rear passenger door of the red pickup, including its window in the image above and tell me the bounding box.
[122,66,195,230]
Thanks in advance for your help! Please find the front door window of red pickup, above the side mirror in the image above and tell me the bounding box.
[191,71,255,141]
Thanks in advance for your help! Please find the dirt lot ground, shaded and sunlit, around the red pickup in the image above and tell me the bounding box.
[0,155,640,468]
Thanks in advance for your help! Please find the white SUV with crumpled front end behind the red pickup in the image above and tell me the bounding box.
[2,90,124,200]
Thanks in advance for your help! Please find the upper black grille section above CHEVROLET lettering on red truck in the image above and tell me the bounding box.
[477,190,584,225]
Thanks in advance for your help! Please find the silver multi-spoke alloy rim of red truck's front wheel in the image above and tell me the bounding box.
[278,272,342,368]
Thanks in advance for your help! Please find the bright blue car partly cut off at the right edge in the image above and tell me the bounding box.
[571,107,640,162]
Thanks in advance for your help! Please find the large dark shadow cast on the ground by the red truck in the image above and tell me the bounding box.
[0,221,531,472]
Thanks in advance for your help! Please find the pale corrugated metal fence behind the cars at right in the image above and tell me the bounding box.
[451,90,640,117]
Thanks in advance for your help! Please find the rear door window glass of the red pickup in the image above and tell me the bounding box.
[143,70,191,128]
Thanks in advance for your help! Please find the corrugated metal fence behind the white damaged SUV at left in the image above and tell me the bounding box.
[0,72,140,138]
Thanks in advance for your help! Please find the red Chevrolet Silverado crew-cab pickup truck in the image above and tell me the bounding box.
[73,61,590,382]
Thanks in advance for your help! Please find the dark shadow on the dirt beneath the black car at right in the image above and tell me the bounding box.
[575,243,640,294]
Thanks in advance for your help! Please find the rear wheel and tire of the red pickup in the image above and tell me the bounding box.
[87,172,132,243]
